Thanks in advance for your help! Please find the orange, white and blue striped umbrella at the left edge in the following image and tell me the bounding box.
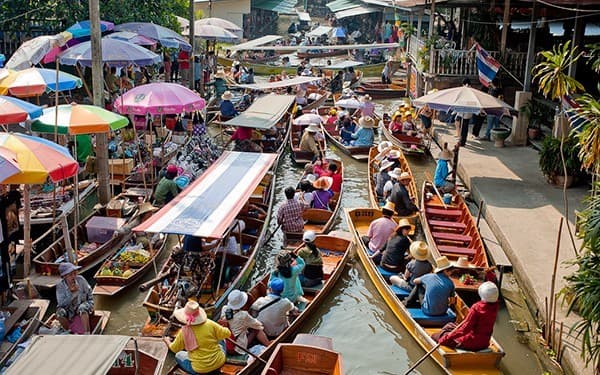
[0,68,83,97]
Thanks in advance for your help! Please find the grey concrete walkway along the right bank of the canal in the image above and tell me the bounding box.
[434,123,593,374]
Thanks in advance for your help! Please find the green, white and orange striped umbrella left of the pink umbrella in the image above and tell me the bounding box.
[31,104,129,134]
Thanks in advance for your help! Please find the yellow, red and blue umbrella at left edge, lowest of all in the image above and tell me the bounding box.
[0,133,79,184]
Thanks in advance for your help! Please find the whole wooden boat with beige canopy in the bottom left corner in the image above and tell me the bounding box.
[6,335,169,375]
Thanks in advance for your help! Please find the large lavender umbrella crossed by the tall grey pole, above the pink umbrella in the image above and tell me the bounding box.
[60,38,162,66]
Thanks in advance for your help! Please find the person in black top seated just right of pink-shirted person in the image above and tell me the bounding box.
[371,219,412,273]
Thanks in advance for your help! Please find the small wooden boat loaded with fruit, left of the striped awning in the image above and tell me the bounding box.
[92,235,167,296]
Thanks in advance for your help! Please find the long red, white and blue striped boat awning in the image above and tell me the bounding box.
[134,151,277,238]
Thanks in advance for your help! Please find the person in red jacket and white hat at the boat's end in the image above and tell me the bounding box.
[431,281,499,352]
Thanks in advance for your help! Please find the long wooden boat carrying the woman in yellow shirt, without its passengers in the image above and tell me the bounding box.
[169,235,353,375]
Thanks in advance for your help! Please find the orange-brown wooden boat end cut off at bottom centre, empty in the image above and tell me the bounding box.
[261,333,344,375]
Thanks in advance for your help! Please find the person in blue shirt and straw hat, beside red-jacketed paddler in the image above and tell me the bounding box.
[405,256,454,316]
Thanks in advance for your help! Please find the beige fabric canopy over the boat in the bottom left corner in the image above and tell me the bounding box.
[5,335,131,375]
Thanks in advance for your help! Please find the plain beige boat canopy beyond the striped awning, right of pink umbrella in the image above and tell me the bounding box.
[224,94,296,130]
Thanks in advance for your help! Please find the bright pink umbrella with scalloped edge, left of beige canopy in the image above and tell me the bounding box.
[115,82,206,115]
